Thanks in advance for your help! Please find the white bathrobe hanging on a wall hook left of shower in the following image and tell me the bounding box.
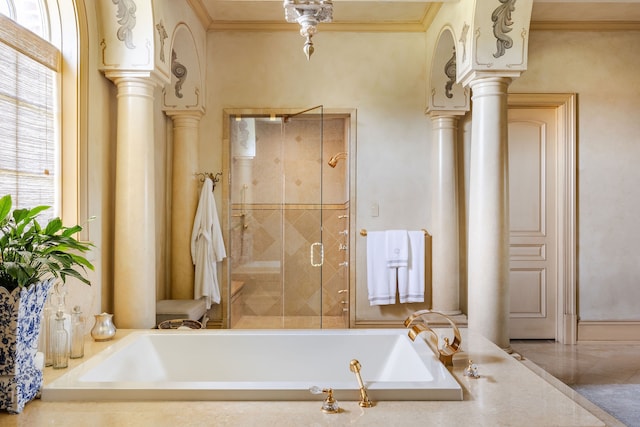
[191,178,227,310]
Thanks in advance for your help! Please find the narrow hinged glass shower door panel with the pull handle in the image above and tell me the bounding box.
[282,107,325,328]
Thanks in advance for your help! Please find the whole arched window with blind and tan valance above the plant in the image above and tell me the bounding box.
[0,0,60,219]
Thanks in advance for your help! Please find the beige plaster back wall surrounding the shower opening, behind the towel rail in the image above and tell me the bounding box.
[204,28,430,320]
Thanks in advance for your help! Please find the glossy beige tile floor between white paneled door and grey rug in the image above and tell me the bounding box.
[511,340,640,386]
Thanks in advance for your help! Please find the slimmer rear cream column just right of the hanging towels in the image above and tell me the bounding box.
[431,113,460,315]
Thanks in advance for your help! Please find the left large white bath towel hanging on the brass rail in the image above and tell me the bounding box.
[367,231,396,305]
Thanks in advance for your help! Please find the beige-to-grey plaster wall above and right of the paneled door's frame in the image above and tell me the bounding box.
[509,31,640,320]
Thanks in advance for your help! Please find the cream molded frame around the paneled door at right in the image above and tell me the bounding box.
[507,93,578,344]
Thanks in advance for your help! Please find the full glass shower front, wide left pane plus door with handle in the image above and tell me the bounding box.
[228,107,325,329]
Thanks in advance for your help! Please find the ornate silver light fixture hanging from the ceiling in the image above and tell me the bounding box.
[282,0,333,60]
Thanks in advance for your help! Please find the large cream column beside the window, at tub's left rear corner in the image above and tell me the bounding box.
[105,71,156,329]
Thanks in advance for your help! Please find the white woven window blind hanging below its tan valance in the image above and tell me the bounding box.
[0,18,58,220]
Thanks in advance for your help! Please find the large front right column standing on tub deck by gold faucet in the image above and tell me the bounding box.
[468,77,511,348]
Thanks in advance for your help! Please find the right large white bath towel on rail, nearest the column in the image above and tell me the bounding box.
[398,230,425,303]
